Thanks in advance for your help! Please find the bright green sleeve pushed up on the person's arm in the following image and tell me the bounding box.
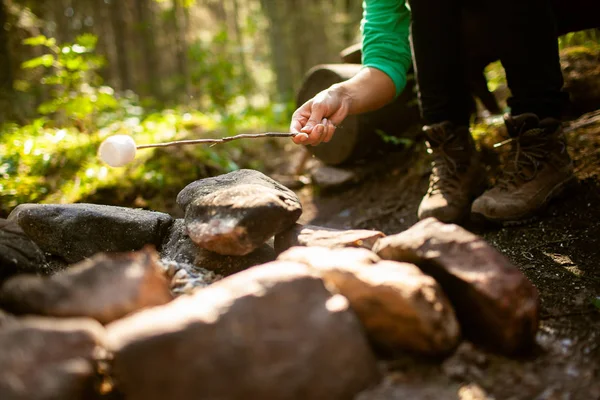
[361,0,411,96]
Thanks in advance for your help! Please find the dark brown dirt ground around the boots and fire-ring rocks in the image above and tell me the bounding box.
[278,113,600,400]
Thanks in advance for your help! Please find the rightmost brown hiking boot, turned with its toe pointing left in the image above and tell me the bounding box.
[471,114,575,224]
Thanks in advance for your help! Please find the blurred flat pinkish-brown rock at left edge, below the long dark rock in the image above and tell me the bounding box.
[0,249,173,324]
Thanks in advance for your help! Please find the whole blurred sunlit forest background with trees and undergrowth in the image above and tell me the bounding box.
[0,0,600,217]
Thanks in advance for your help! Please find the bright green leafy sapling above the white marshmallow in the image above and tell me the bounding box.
[15,34,119,130]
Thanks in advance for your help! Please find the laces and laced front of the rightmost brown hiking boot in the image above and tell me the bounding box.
[494,128,564,189]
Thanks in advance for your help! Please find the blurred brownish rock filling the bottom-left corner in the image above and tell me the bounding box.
[0,318,104,400]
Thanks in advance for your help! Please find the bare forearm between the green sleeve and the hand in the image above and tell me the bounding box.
[331,67,396,114]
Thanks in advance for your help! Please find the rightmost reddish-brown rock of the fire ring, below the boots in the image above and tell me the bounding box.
[373,218,540,354]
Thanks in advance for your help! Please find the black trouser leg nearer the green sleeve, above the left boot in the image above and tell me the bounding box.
[409,0,473,125]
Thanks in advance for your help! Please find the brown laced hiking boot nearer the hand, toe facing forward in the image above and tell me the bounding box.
[418,121,485,223]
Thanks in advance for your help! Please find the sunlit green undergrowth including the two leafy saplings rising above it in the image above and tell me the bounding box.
[0,29,294,216]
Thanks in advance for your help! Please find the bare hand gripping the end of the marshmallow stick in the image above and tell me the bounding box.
[290,85,352,146]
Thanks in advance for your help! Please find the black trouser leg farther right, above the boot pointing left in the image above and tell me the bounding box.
[485,0,568,118]
